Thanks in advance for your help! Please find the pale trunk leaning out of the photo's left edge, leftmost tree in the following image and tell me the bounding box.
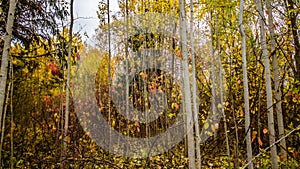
[0,0,17,135]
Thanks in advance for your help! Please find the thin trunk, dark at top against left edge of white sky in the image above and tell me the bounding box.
[61,0,74,168]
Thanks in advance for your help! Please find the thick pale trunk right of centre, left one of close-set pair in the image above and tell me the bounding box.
[179,0,196,169]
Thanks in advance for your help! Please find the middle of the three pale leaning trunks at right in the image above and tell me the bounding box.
[257,0,278,169]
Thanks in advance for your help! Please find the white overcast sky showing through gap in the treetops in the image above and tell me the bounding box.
[74,0,119,43]
